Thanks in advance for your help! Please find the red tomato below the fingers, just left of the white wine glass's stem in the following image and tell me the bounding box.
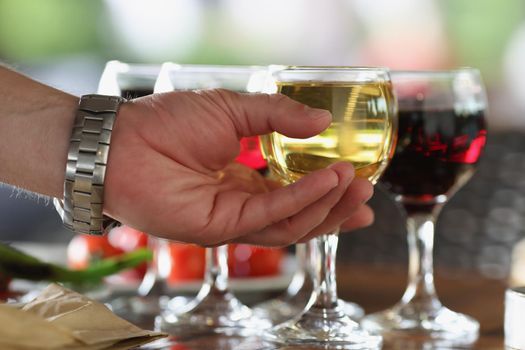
[228,244,284,277]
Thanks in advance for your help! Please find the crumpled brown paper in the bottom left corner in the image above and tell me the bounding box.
[0,284,165,350]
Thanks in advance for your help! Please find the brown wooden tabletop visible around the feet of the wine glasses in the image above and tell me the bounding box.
[141,263,506,350]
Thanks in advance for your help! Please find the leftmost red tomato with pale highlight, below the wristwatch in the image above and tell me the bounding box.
[67,235,124,269]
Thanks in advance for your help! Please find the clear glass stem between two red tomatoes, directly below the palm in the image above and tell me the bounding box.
[204,245,228,294]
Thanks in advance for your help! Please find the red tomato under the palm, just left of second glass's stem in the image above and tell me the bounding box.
[168,242,206,283]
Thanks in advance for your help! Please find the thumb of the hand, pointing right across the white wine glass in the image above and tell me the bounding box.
[203,90,331,138]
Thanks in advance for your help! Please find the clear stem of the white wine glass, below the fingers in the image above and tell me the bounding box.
[310,231,339,309]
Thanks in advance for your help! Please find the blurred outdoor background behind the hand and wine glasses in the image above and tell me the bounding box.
[0,0,525,279]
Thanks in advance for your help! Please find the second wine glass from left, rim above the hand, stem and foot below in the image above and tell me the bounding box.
[155,63,270,336]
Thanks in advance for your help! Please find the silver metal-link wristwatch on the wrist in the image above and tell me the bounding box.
[53,95,126,235]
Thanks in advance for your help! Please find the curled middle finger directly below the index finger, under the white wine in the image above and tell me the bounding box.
[231,163,354,246]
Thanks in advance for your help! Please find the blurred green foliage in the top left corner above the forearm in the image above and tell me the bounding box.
[0,0,104,61]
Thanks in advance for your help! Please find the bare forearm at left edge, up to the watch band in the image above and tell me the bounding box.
[0,66,78,198]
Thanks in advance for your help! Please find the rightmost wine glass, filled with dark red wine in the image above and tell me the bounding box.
[362,68,487,344]
